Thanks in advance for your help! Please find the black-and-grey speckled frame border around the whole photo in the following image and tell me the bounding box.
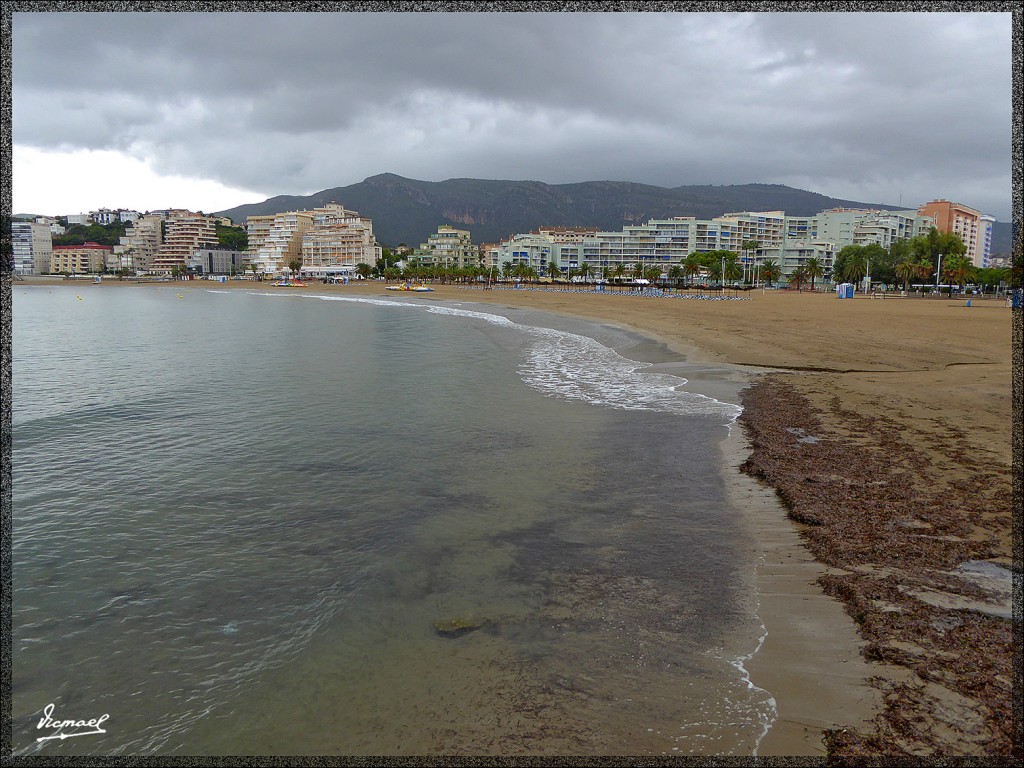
[0,0,1024,768]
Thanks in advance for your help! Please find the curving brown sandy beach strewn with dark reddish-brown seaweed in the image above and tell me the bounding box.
[14,280,1020,759]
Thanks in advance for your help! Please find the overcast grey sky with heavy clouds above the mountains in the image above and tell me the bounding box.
[12,12,1012,221]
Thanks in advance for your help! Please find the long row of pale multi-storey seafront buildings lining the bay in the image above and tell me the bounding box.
[12,200,994,283]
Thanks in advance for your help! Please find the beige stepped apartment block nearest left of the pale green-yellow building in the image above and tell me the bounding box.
[301,203,383,278]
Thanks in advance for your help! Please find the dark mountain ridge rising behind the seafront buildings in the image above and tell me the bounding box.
[211,173,1011,253]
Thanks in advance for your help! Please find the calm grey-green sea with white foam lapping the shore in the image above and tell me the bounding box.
[11,284,775,755]
